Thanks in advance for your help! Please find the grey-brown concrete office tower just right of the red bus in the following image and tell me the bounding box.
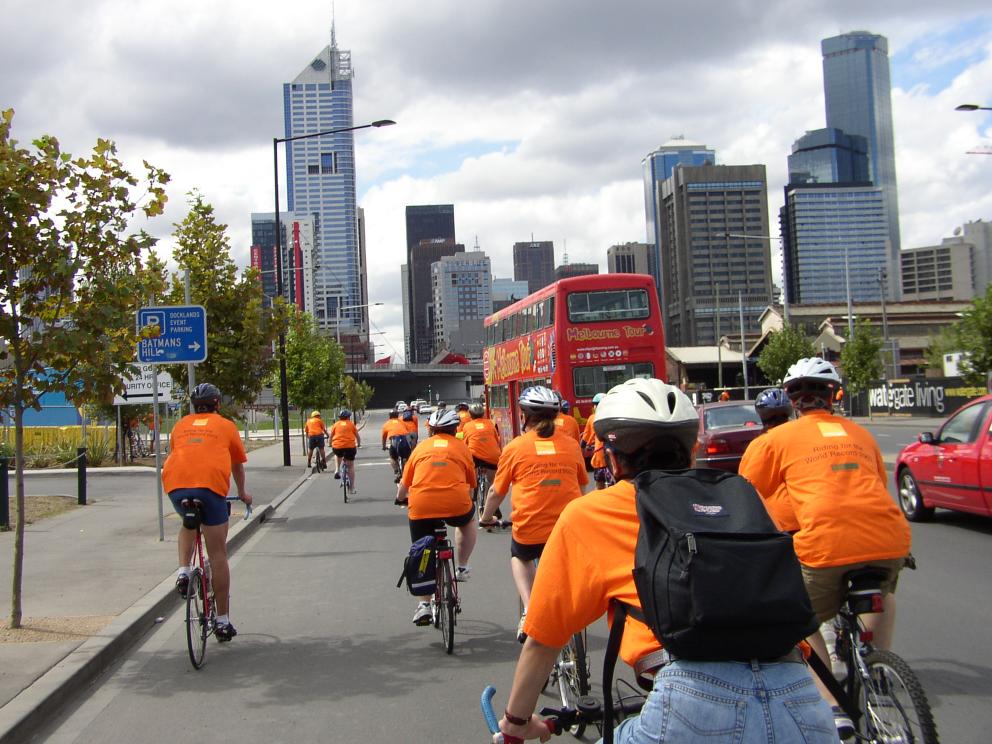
[659,165,772,346]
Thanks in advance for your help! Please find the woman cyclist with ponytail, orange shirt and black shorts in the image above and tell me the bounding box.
[479,386,589,643]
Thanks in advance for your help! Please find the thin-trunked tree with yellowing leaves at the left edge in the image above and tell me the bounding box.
[0,110,169,628]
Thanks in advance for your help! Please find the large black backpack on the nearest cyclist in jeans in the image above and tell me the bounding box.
[603,468,819,742]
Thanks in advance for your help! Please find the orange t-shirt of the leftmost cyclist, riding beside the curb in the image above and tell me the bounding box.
[162,413,248,496]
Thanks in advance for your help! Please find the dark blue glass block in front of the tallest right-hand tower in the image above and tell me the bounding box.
[789,129,871,184]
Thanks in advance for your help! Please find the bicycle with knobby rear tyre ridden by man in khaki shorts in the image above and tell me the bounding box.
[827,561,938,744]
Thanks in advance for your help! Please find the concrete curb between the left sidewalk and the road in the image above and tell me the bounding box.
[0,471,309,744]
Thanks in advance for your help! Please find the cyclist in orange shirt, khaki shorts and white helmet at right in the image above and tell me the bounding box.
[740,357,910,738]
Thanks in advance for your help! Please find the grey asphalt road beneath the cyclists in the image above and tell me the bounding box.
[31,421,992,744]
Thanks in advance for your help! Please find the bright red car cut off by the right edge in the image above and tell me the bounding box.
[895,395,992,522]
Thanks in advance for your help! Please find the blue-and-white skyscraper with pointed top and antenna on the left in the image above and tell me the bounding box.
[283,28,368,340]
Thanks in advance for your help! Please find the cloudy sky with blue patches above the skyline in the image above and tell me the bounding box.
[0,0,992,355]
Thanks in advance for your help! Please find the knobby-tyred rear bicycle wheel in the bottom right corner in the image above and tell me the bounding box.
[860,650,939,744]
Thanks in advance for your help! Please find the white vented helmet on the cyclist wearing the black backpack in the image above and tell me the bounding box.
[593,378,699,460]
